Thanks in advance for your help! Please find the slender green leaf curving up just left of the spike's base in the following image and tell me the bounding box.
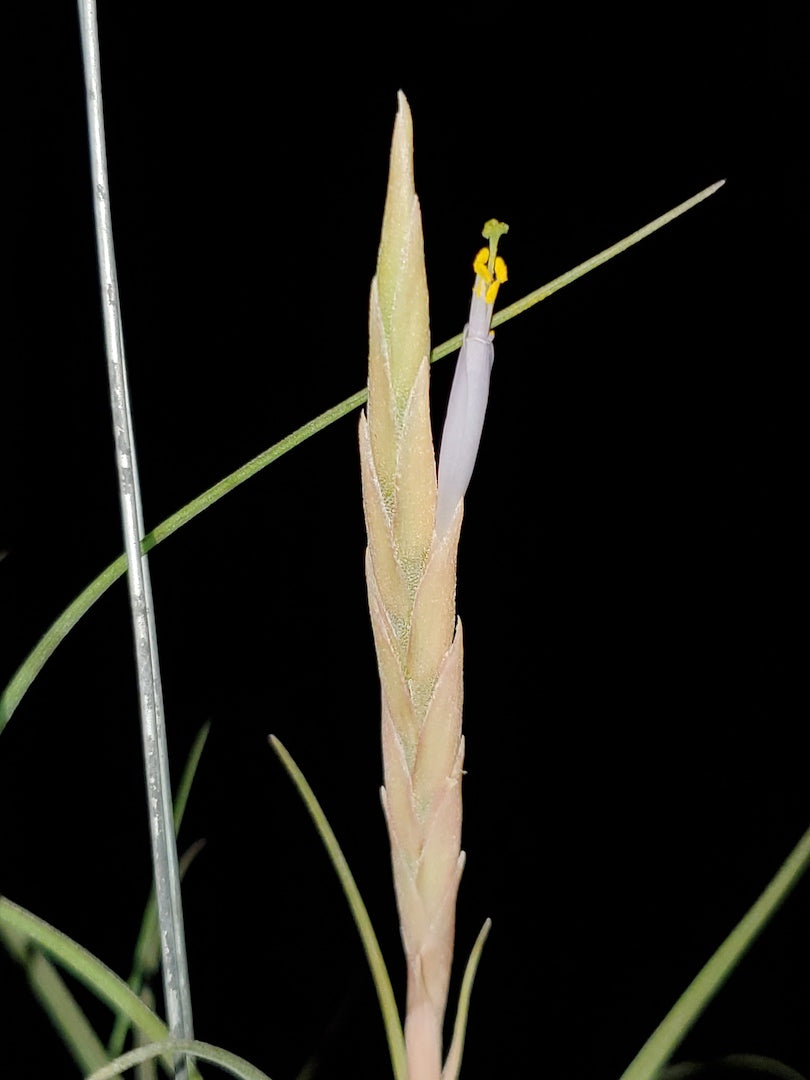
[270,735,408,1080]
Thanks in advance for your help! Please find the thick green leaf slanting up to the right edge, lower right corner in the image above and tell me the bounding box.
[621,816,810,1080]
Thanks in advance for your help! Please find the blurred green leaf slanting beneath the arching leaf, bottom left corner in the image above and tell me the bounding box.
[0,924,110,1072]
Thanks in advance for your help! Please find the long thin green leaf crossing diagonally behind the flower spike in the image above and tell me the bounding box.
[0,180,725,732]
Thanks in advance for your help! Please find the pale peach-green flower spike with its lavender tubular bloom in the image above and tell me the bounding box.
[360,94,507,1080]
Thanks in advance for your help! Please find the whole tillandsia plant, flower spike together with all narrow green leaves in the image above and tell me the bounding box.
[0,33,810,1080]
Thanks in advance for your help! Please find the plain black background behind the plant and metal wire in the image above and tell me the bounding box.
[0,2,810,1080]
